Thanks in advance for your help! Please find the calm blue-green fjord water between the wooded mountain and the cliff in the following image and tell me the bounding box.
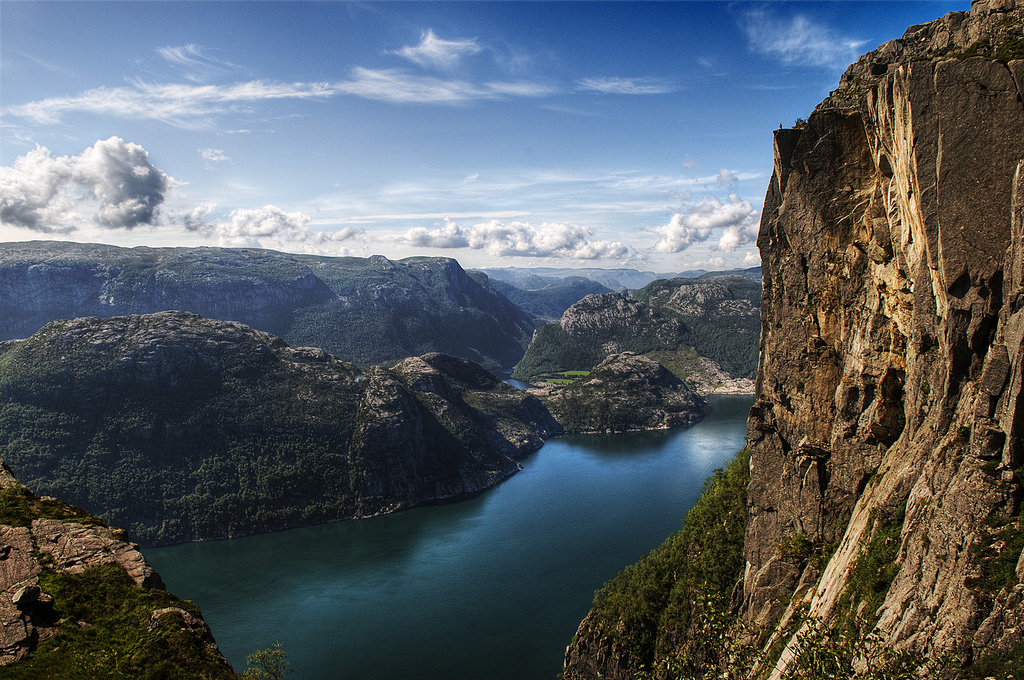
[145,396,753,680]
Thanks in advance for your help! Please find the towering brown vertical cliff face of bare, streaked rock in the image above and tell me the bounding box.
[743,2,1024,661]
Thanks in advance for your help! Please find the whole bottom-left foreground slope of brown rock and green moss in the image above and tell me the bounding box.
[0,461,237,680]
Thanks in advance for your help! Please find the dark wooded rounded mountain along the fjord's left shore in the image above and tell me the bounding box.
[0,312,560,545]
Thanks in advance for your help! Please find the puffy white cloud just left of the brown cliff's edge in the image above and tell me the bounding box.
[649,194,758,253]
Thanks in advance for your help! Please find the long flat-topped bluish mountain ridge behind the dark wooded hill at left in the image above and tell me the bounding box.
[0,242,536,369]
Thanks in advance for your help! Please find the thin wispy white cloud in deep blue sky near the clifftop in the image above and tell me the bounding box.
[742,9,866,68]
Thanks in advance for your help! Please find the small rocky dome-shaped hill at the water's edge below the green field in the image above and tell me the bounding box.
[546,352,706,432]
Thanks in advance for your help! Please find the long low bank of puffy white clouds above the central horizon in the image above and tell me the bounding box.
[402,219,633,260]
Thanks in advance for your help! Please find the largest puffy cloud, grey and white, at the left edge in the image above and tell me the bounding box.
[0,137,176,232]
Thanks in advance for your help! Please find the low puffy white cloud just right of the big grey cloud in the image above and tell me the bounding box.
[183,204,356,246]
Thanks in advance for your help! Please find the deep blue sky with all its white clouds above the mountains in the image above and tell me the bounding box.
[0,0,970,272]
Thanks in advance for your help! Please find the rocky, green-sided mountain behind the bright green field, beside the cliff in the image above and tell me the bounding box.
[513,275,761,391]
